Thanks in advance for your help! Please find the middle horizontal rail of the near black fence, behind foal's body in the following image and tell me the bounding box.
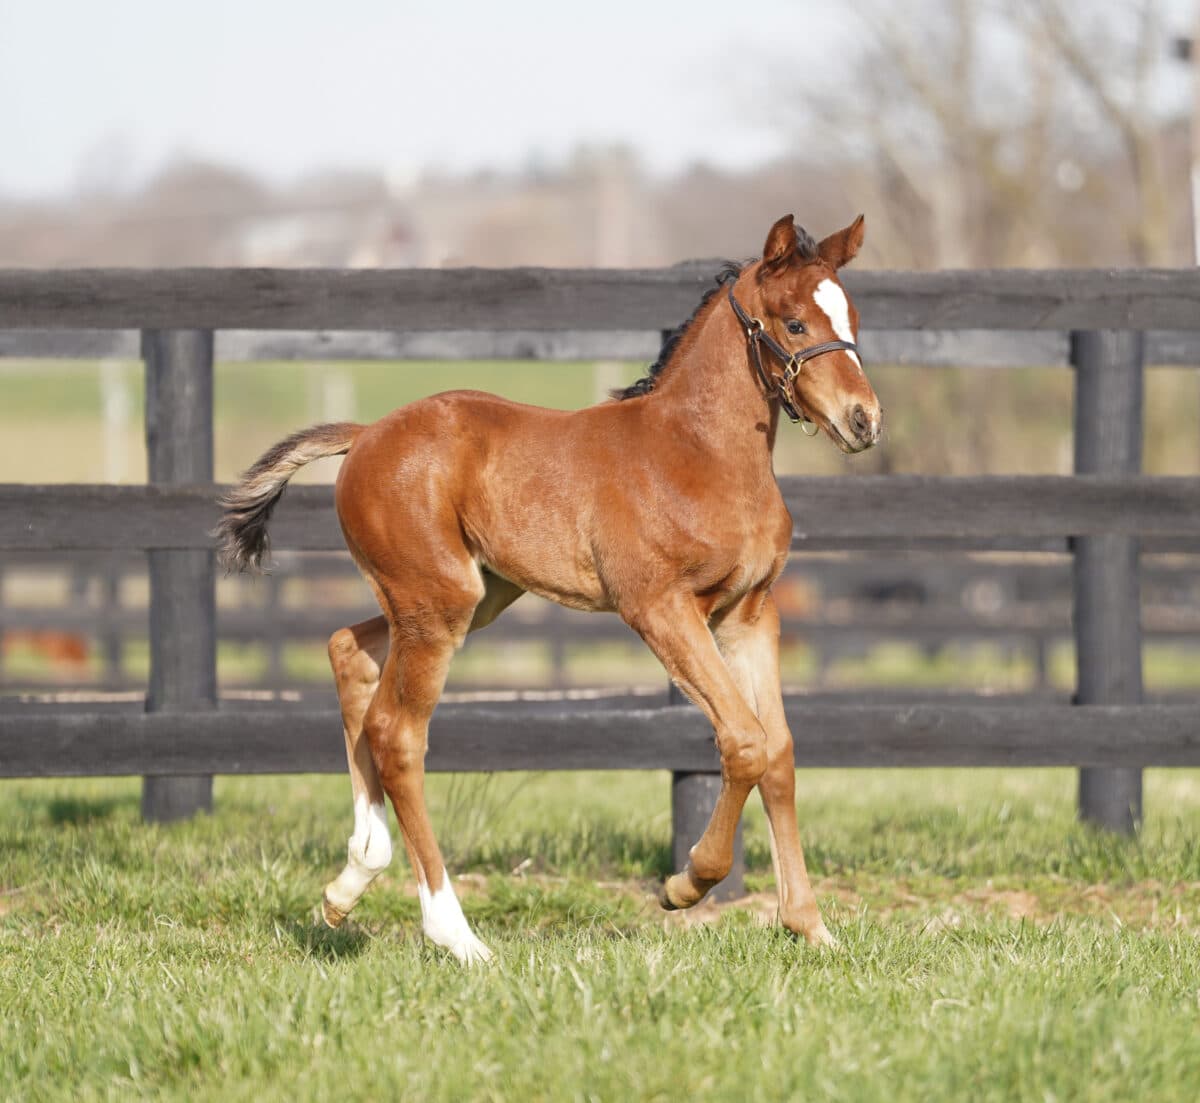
[7,475,1200,551]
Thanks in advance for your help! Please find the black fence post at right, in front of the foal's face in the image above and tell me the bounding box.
[1070,330,1144,834]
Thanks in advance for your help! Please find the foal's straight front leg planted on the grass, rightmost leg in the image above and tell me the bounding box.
[716,594,836,946]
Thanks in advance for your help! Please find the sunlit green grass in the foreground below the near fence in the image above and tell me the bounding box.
[0,771,1200,1101]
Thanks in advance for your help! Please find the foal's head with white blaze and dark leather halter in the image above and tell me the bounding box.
[738,215,883,452]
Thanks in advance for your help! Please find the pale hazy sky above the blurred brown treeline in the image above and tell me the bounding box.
[0,0,851,197]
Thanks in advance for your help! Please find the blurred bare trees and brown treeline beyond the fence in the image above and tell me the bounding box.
[0,0,1200,482]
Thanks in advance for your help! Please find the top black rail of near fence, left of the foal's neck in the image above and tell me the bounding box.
[0,268,713,330]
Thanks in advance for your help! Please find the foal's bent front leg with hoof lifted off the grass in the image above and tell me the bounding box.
[626,594,767,909]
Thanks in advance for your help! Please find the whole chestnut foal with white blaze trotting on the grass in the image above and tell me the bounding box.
[218,215,881,963]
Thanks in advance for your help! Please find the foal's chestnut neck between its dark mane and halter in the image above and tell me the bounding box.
[650,290,779,472]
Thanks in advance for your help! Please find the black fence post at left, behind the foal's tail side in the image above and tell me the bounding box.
[142,329,217,821]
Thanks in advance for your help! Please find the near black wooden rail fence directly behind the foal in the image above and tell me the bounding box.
[0,264,1200,878]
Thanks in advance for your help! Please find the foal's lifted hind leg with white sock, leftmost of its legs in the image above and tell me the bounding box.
[322,617,391,927]
